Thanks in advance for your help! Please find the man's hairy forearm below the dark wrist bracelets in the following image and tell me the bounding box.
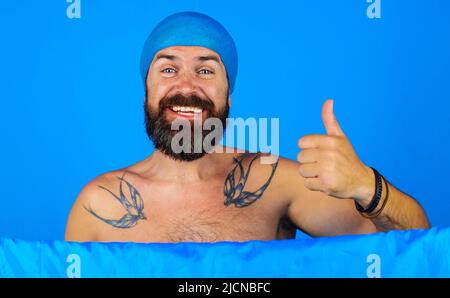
[356,176,430,231]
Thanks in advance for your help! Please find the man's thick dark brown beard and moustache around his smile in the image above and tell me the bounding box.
[144,92,230,161]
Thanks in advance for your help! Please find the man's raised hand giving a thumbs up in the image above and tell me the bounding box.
[297,99,375,207]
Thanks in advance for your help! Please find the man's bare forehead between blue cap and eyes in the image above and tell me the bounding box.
[152,46,223,65]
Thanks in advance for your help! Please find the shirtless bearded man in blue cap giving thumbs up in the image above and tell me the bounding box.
[66,12,430,242]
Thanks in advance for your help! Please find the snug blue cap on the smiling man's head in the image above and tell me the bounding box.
[140,11,238,93]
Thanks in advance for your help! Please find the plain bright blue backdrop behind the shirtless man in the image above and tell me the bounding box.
[0,0,450,240]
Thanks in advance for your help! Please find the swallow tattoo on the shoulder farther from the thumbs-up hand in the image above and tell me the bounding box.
[84,174,147,229]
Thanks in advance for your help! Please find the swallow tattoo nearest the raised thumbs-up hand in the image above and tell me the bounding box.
[224,153,279,208]
